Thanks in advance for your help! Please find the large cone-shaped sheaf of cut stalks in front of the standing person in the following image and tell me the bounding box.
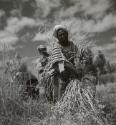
[52,80,106,125]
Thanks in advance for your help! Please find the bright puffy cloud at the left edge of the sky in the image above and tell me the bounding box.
[0,17,38,51]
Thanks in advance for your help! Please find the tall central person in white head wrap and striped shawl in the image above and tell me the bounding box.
[45,25,81,102]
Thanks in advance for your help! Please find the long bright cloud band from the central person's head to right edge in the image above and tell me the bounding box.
[51,13,116,34]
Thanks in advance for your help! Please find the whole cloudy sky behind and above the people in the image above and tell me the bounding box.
[0,0,116,73]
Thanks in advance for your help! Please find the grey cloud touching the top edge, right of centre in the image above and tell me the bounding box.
[60,0,112,19]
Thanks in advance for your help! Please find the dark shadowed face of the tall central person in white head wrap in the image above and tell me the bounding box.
[57,29,68,45]
